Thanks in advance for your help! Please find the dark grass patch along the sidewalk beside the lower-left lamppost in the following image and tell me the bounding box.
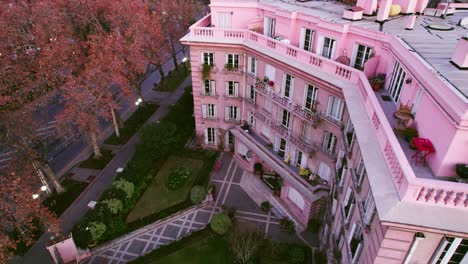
[43,179,88,216]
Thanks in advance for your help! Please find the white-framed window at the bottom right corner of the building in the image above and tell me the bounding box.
[431,236,468,264]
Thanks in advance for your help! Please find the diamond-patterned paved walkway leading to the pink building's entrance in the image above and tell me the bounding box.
[82,152,302,264]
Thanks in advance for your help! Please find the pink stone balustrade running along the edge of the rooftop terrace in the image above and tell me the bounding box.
[185,21,468,209]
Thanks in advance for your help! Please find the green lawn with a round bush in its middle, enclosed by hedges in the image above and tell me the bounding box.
[126,156,203,223]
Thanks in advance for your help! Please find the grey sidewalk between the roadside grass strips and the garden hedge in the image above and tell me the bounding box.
[21,76,191,264]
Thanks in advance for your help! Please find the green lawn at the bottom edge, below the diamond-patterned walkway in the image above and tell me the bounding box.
[154,235,233,264]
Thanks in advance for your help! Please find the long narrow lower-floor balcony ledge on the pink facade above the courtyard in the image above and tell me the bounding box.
[231,126,330,202]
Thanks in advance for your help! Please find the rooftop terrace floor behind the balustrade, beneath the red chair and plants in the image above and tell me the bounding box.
[375,89,440,179]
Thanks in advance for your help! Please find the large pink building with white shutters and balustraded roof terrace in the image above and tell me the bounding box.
[182,0,468,263]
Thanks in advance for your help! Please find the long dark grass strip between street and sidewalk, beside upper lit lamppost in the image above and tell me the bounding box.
[104,103,158,145]
